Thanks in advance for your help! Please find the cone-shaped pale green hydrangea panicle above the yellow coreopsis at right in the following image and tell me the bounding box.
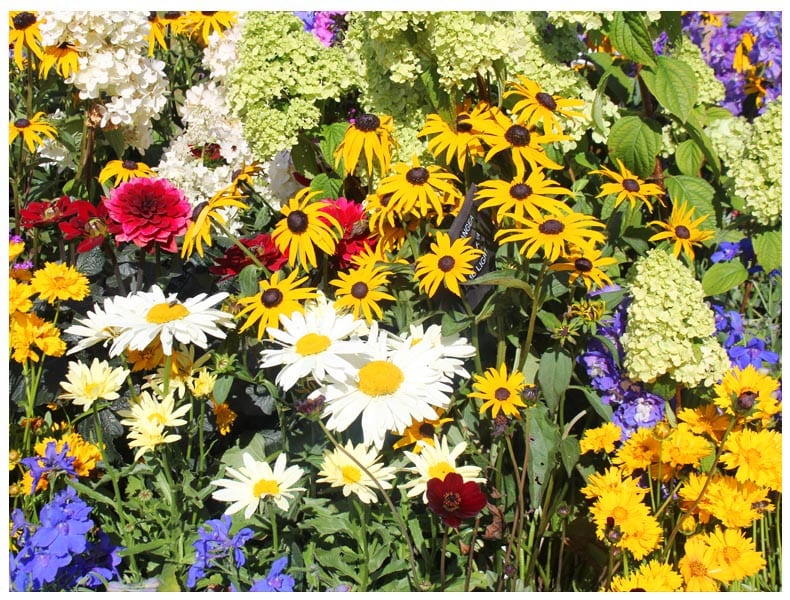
[621,248,730,387]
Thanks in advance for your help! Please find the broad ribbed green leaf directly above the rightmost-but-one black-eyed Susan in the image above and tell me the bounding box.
[608,116,661,178]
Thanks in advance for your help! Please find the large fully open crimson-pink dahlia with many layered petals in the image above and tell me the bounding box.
[104,177,192,252]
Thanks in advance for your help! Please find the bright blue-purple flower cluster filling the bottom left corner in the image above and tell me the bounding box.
[9,488,121,592]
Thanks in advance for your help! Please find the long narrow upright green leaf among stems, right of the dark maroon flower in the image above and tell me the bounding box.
[527,404,560,508]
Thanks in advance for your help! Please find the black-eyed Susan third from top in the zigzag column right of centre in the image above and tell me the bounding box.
[476,169,573,223]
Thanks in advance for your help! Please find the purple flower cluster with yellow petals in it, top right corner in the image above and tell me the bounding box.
[683,11,782,115]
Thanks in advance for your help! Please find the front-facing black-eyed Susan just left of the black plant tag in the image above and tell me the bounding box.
[414,231,483,298]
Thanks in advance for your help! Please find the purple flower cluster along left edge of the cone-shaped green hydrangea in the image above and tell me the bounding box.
[578,299,664,440]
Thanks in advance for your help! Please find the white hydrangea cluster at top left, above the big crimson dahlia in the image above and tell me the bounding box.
[41,11,167,151]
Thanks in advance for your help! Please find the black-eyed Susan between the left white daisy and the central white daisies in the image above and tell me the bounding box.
[236,271,316,340]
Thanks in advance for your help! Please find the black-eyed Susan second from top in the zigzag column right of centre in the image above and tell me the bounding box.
[470,107,570,177]
